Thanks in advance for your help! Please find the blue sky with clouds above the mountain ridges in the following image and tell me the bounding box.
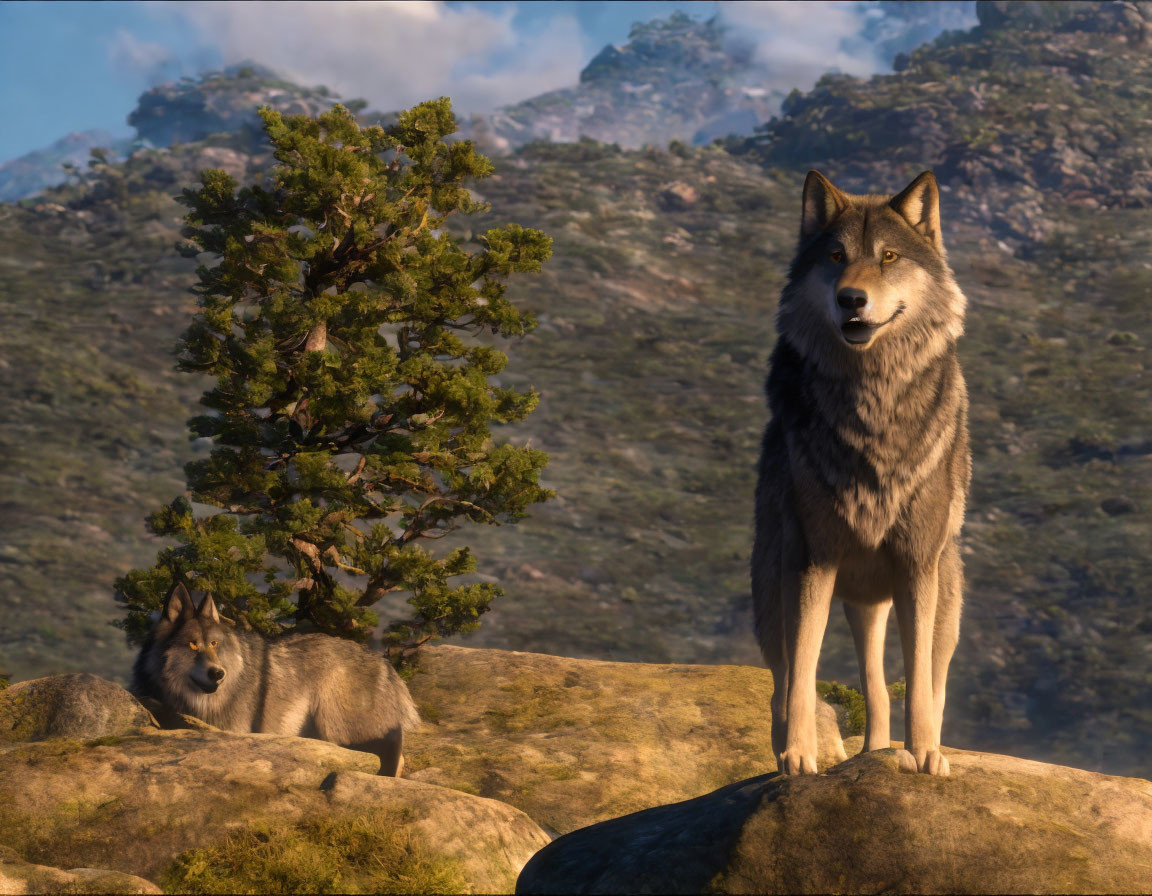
[0,0,971,161]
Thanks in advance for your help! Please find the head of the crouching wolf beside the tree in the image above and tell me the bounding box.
[153,583,244,705]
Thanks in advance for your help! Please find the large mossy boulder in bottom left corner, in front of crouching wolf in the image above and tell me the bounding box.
[0,676,548,893]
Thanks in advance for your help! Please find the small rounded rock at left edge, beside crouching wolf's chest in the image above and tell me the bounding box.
[0,673,156,744]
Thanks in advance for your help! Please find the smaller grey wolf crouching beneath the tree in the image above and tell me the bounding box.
[131,584,419,775]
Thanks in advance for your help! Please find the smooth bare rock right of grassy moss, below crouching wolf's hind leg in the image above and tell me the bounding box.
[325,772,551,893]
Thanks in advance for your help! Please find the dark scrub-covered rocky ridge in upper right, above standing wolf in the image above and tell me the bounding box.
[730,2,1152,246]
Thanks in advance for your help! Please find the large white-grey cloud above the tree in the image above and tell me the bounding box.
[152,0,584,113]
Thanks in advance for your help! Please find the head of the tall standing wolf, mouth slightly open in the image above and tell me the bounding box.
[778,170,964,367]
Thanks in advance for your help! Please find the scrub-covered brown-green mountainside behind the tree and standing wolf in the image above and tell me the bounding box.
[0,3,1152,776]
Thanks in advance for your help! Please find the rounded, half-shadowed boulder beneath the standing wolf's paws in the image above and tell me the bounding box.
[516,749,1152,894]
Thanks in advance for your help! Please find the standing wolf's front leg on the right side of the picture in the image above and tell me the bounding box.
[894,561,948,775]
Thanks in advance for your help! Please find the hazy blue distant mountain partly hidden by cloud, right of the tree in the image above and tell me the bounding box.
[465,0,971,152]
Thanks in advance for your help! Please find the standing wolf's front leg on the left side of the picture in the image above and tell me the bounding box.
[779,564,836,775]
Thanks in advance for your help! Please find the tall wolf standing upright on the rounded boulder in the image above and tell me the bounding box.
[752,172,971,775]
